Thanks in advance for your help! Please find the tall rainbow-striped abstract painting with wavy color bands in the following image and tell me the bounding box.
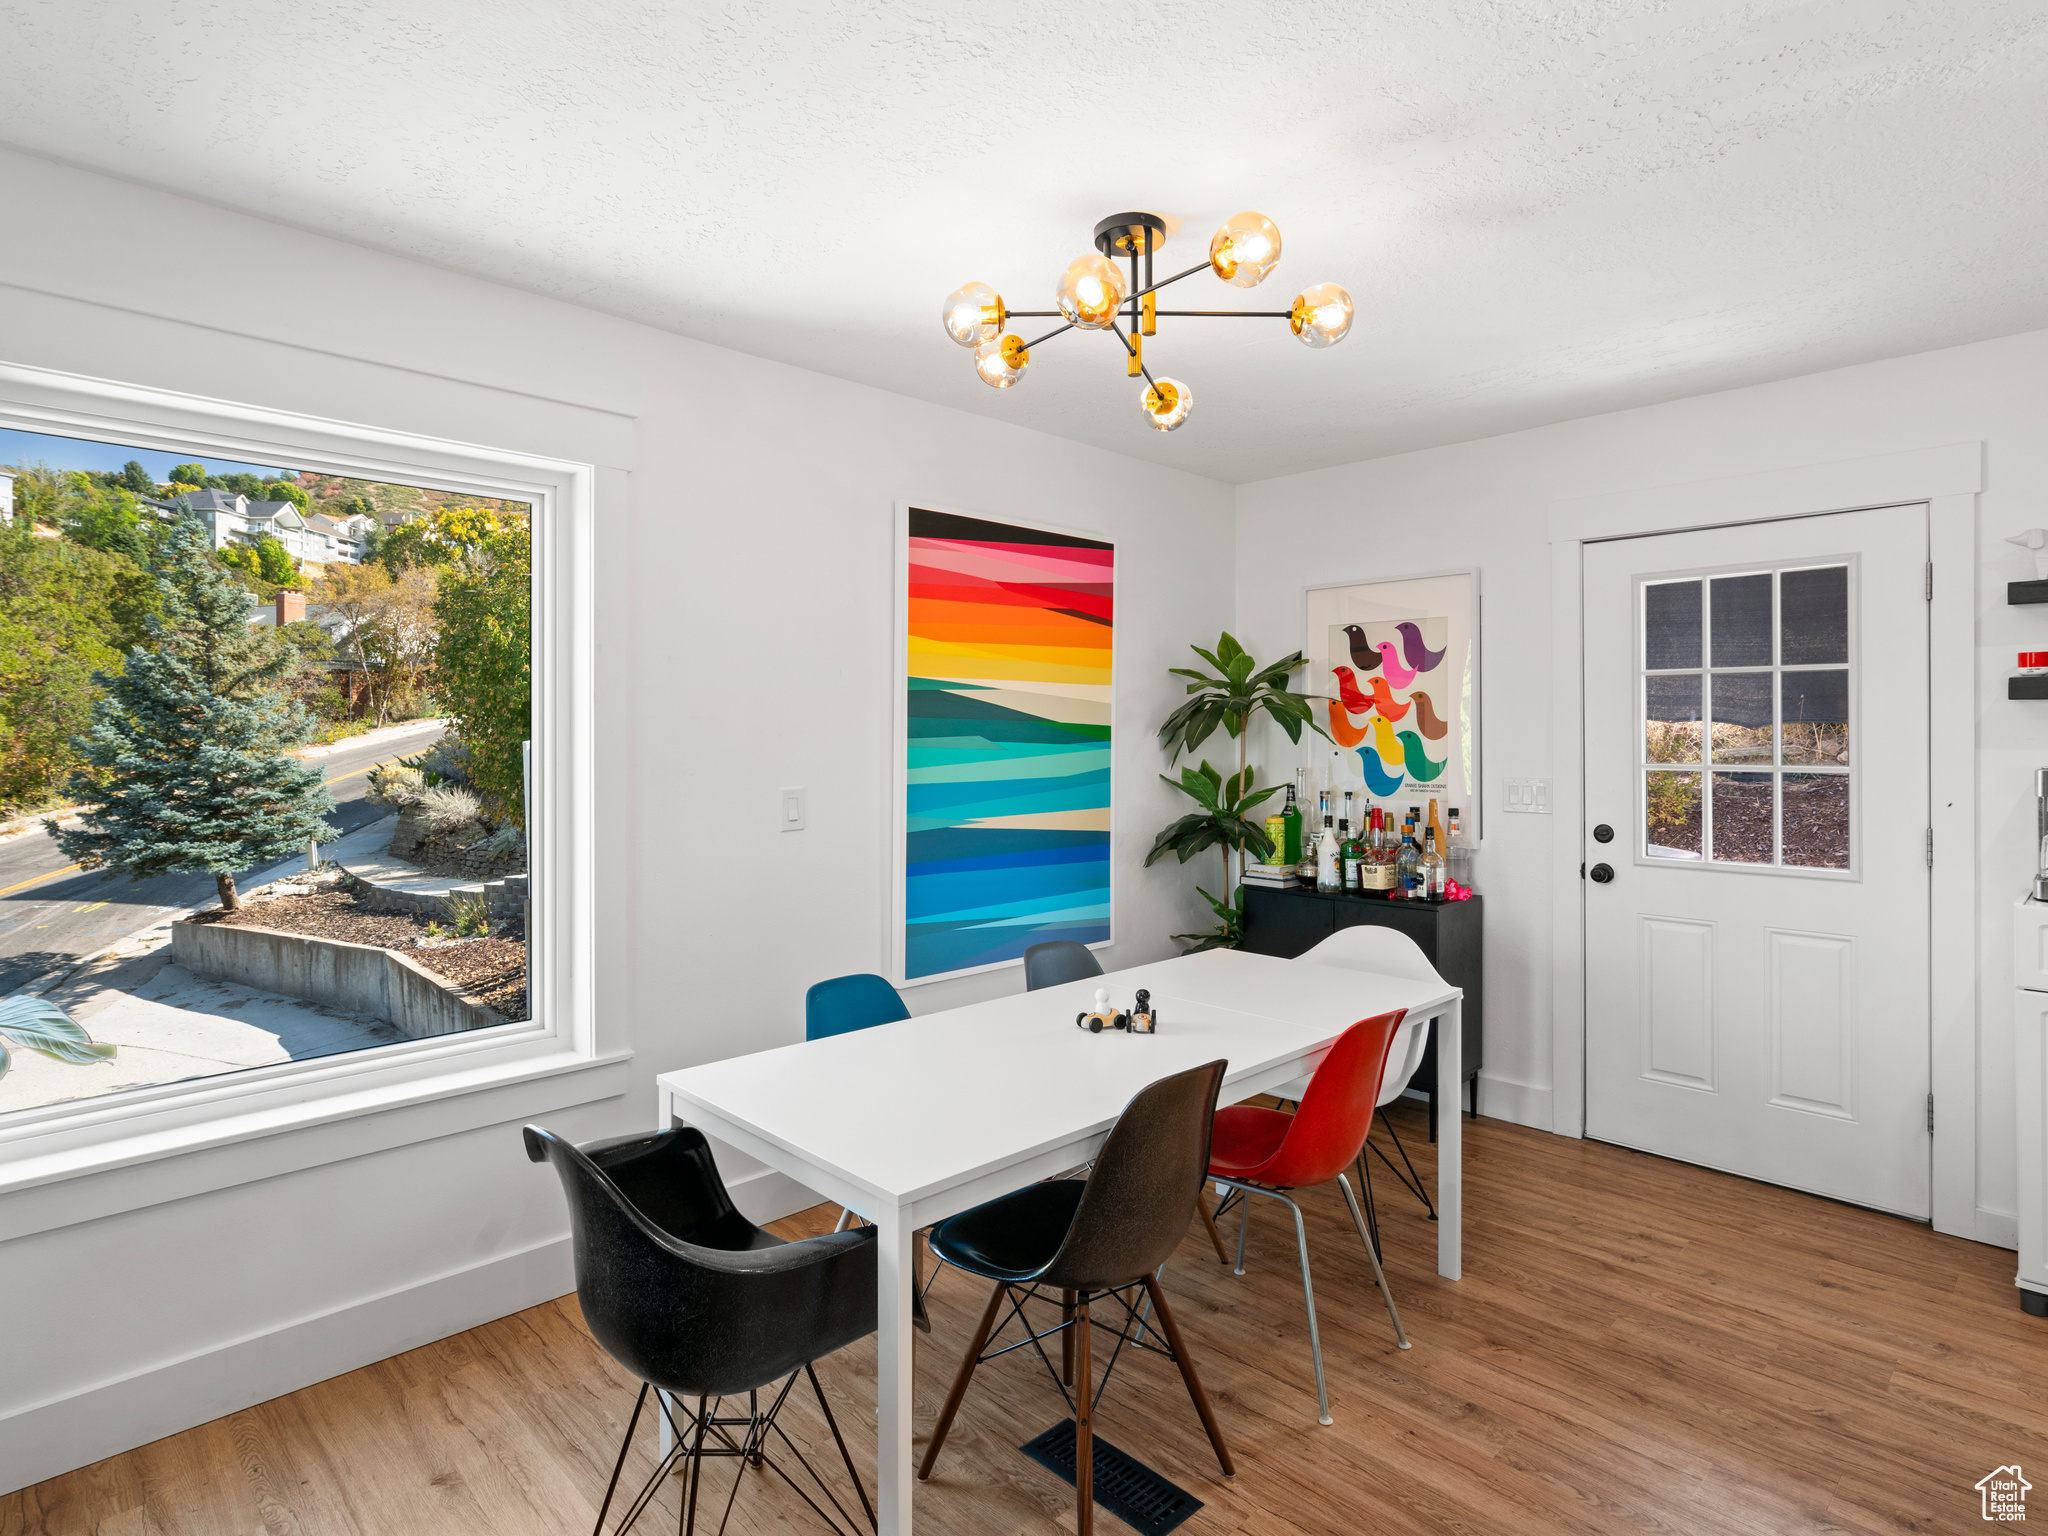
[895,508,1116,981]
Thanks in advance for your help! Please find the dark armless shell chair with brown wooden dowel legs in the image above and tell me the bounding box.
[918,1061,1237,1536]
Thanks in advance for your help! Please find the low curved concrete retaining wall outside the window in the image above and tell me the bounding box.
[170,922,504,1040]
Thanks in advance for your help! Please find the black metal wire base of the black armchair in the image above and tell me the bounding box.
[592,1366,877,1536]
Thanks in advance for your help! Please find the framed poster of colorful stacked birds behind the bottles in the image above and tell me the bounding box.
[1303,573,1479,836]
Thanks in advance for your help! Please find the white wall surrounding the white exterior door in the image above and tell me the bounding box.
[1237,332,2048,1241]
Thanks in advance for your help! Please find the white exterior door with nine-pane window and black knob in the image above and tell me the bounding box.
[1583,506,1933,1219]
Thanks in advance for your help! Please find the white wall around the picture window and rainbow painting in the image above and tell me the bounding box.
[0,154,1233,1489]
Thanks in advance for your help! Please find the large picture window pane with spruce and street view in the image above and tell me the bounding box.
[0,415,548,1126]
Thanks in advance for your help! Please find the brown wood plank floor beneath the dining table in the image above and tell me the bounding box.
[0,1106,2048,1536]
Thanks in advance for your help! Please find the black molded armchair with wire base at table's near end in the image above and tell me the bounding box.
[526,1126,874,1532]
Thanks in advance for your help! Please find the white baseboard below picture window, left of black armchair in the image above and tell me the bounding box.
[0,1237,575,1495]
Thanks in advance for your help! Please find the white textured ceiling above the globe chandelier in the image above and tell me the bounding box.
[0,0,2048,481]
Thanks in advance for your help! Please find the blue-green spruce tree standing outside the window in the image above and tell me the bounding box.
[43,518,334,911]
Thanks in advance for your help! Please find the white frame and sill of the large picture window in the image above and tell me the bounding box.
[0,365,610,1241]
